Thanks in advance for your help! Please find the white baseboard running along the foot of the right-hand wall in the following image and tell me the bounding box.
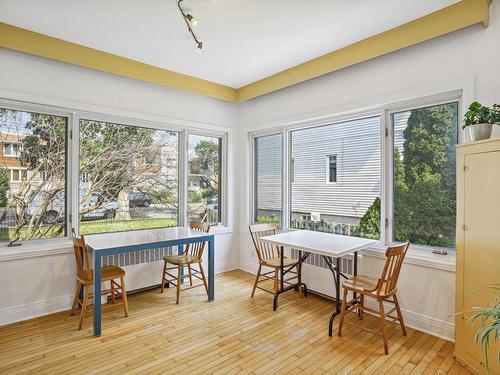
[239,261,455,342]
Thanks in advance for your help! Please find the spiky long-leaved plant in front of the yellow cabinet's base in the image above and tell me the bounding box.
[459,285,500,368]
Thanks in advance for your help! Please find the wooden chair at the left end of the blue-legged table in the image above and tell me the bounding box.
[71,230,128,330]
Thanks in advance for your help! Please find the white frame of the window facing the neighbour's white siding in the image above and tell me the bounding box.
[248,89,468,252]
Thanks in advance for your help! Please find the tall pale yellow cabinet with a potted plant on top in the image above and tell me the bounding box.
[455,139,500,375]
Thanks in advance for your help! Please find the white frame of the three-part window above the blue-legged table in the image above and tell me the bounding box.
[0,98,229,248]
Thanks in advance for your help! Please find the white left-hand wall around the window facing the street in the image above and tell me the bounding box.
[0,49,239,325]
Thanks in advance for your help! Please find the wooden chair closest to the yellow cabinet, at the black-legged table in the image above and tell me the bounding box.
[338,242,410,354]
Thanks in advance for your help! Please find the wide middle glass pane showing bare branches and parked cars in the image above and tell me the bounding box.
[79,120,179,234]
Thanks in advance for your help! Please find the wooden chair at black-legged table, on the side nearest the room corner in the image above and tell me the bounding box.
[249,224,300,297]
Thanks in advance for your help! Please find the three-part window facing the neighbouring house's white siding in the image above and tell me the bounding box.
[253,94,459,248]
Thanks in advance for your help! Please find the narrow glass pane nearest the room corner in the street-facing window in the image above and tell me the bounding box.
[188,134,222,224]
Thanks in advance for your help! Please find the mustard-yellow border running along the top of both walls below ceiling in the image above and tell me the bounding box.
[0,0,491,102]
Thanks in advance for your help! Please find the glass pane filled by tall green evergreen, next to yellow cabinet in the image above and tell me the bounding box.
[392,103,458,248]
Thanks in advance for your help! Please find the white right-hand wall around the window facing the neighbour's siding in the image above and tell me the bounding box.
[235,2,500,338]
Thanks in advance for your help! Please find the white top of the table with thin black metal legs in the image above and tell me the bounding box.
[260,230,377,258]
